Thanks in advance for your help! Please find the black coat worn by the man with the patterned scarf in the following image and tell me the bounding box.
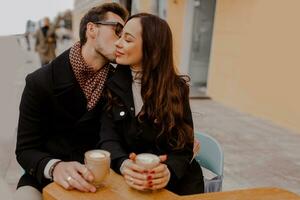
[16,50,111,190]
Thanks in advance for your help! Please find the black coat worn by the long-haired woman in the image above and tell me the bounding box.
[100,66,204,194]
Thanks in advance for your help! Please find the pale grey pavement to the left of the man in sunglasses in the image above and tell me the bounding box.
[0,35,70,200]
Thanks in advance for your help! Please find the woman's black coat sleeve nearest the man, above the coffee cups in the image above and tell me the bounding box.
[99,106,128,174]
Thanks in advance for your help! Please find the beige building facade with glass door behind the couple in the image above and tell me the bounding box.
[73,0,300,133]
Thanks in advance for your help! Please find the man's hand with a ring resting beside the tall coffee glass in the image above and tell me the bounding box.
[53,162,96,192]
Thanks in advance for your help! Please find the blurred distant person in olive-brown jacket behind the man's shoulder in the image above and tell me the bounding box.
[35,17,56,65]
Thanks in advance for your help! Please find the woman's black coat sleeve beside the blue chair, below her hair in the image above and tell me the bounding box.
[165,92,193,181]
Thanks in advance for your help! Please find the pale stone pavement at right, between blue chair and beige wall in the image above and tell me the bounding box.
[191,100,300,194]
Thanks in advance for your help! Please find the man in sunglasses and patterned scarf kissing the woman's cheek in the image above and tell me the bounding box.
[15,3,128,199]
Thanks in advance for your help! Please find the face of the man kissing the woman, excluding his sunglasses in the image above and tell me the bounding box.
[93,12,124,62]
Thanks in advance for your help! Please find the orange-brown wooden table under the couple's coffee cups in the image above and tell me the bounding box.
[43,171,300,200]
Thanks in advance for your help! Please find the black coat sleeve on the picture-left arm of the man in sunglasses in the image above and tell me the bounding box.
[15,75,53,183]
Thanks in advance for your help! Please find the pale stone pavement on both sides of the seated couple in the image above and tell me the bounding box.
[0,37,300,200]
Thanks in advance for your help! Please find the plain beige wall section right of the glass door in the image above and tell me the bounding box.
[208,0,300,133]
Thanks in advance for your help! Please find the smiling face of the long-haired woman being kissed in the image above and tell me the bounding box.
[115,18,143,70]
